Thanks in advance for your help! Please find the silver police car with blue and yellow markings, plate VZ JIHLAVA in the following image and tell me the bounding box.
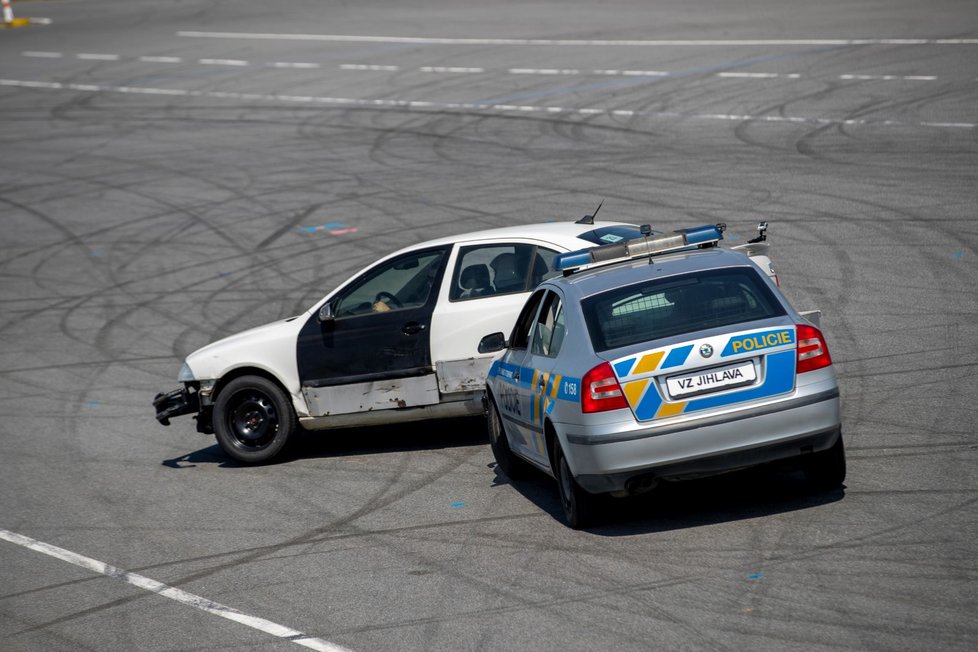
[481,225,846,528]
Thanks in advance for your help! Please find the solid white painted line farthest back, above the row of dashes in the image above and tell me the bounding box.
[177,31,978,47]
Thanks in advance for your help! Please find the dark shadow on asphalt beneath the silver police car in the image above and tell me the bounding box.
[493,466,845,537]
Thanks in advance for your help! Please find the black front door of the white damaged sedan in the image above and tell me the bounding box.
[296,247,449,416]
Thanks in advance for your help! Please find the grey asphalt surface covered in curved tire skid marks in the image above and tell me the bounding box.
[0,0,978,652]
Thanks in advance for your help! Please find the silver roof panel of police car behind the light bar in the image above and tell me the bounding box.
[546,247,756,297]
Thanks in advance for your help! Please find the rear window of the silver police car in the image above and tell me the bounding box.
[581,267,786,351]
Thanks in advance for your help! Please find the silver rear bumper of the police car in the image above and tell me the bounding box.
[565,388,841,493]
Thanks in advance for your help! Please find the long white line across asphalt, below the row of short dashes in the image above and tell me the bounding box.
[0,79,978,129]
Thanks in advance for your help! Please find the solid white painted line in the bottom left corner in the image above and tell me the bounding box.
[0,529,349,652]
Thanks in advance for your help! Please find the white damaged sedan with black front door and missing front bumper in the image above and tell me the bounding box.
[153,216,672,464]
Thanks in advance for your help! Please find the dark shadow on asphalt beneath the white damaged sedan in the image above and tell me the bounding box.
[162,416,489,469]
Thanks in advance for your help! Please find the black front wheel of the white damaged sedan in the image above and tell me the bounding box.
[214,376,298,464]
